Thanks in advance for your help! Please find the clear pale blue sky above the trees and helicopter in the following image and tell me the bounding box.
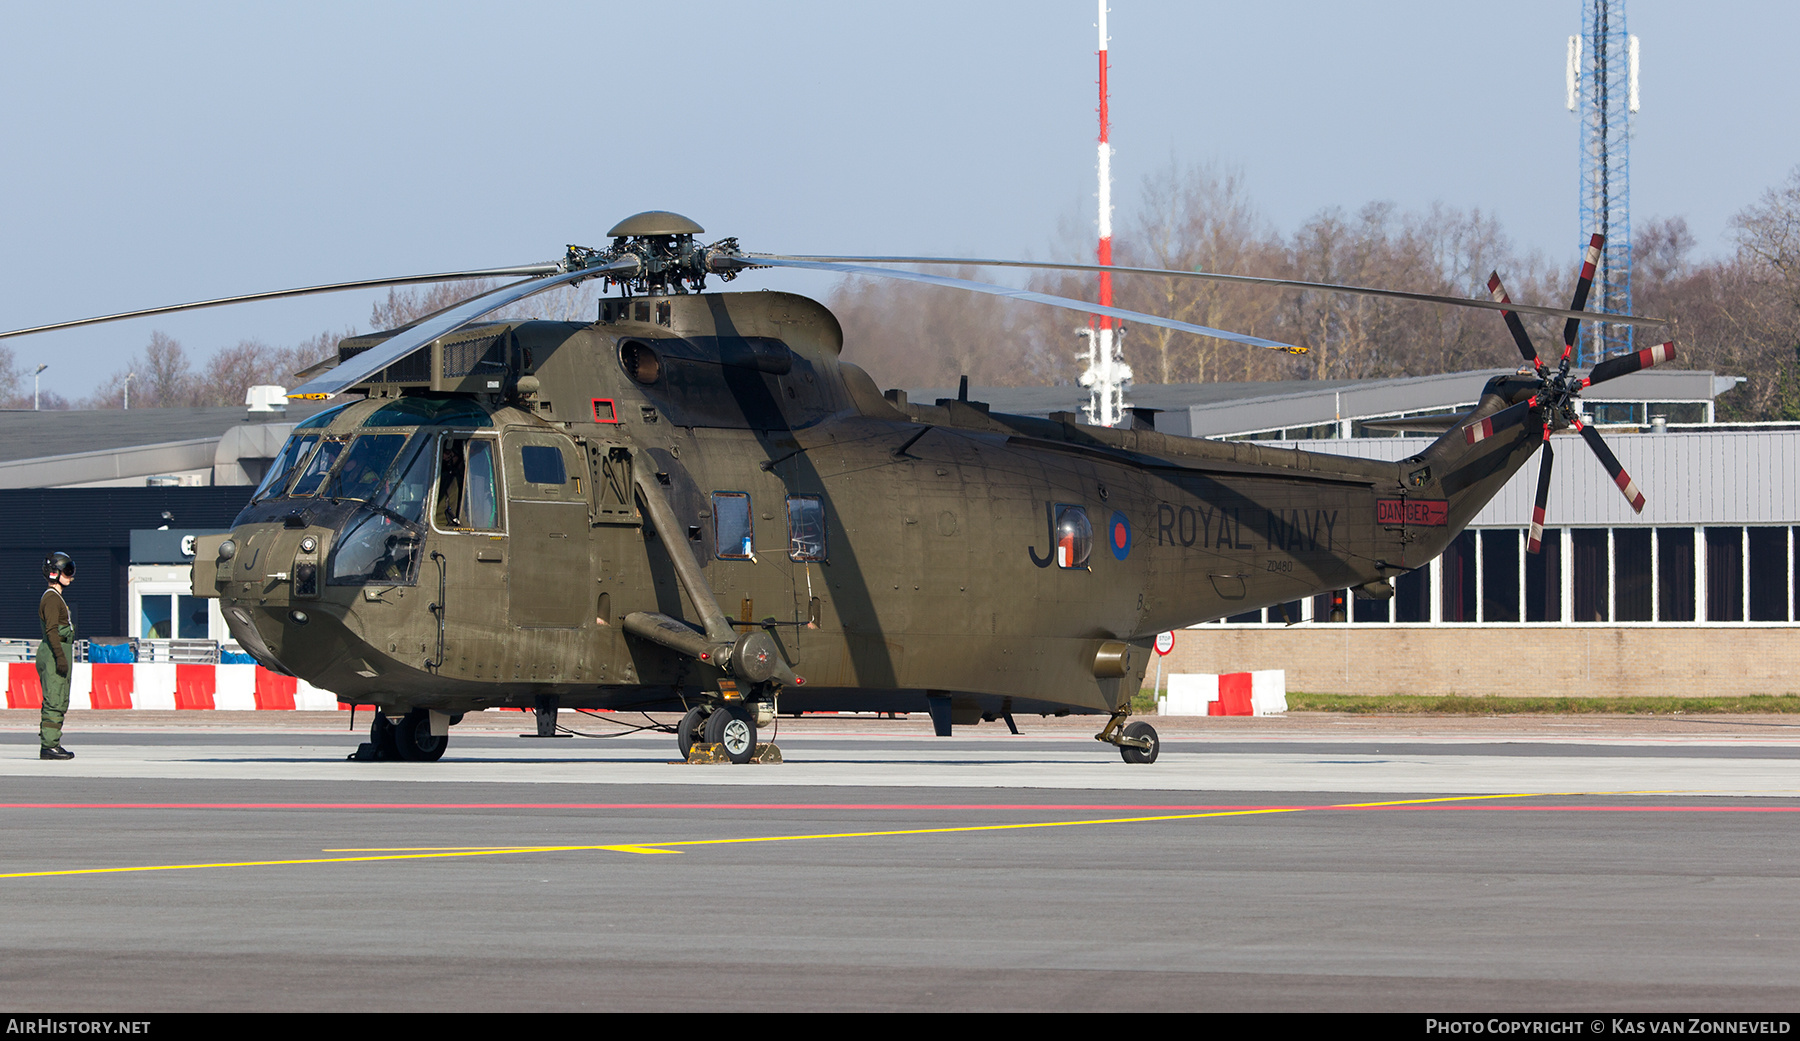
[0,0,1800,398]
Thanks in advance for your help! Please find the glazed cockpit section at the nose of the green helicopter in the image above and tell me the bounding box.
[234,396,504,583]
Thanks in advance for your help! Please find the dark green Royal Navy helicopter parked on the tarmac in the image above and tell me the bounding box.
[0,211,1674,764]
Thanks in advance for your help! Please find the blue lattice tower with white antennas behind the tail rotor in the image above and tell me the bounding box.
[1568,0,1638,366]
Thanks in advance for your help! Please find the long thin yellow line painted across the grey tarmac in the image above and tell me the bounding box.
[0,792,1566,879]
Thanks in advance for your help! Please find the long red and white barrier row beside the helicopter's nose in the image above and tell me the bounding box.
[5,661,347,711]
